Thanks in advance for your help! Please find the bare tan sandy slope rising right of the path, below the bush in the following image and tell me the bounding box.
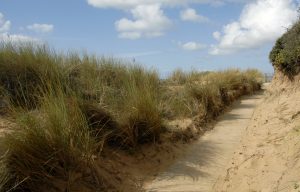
[212,84,300,192]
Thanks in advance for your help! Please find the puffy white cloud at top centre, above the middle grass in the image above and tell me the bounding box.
[115,4,172,39]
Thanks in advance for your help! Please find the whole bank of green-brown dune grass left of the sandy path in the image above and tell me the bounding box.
[0,43,263,191]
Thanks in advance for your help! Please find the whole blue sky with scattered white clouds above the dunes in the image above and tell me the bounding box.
[0,0,298,75]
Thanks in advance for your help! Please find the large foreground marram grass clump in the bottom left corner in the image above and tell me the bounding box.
[0,92,105,191]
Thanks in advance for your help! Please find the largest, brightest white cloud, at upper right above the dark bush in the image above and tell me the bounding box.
[210,0,297,55]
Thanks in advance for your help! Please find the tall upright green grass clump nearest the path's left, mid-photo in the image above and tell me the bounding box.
[119,69,162,146]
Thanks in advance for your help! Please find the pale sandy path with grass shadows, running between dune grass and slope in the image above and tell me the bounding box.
[145,94,263,192]
